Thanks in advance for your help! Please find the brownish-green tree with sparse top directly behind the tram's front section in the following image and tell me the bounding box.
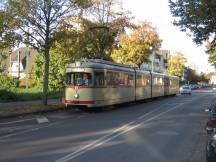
[61,0,133,60]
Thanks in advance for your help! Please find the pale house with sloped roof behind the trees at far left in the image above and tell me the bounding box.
[6,47,38,79]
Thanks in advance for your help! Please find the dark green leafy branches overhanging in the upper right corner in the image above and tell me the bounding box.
[169,0,216,47]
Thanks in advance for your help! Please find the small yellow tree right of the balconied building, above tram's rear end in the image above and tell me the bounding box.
[166,52,187,77]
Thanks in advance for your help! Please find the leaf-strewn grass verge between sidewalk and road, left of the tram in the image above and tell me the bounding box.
[0,104,65,118]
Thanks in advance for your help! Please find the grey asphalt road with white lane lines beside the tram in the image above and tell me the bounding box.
[0,90,216,162]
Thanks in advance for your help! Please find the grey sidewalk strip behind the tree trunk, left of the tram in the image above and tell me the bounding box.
[0,99,61,110]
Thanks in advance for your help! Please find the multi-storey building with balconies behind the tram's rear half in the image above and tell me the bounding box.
[141,50,170,73]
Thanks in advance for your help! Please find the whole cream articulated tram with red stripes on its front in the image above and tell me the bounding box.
[64,59,179,108]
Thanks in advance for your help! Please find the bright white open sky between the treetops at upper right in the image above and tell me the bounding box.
[121,0,215,72]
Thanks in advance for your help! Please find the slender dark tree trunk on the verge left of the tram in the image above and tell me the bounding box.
[42,41,50,105]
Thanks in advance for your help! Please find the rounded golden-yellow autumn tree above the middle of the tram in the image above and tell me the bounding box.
[112,22,161,67]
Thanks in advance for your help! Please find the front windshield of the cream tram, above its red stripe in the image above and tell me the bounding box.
[66,72,92,86]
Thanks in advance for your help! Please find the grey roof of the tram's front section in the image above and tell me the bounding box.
[66,59,132,69]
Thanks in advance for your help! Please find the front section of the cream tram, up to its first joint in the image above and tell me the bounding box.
[65,60,135,107]
